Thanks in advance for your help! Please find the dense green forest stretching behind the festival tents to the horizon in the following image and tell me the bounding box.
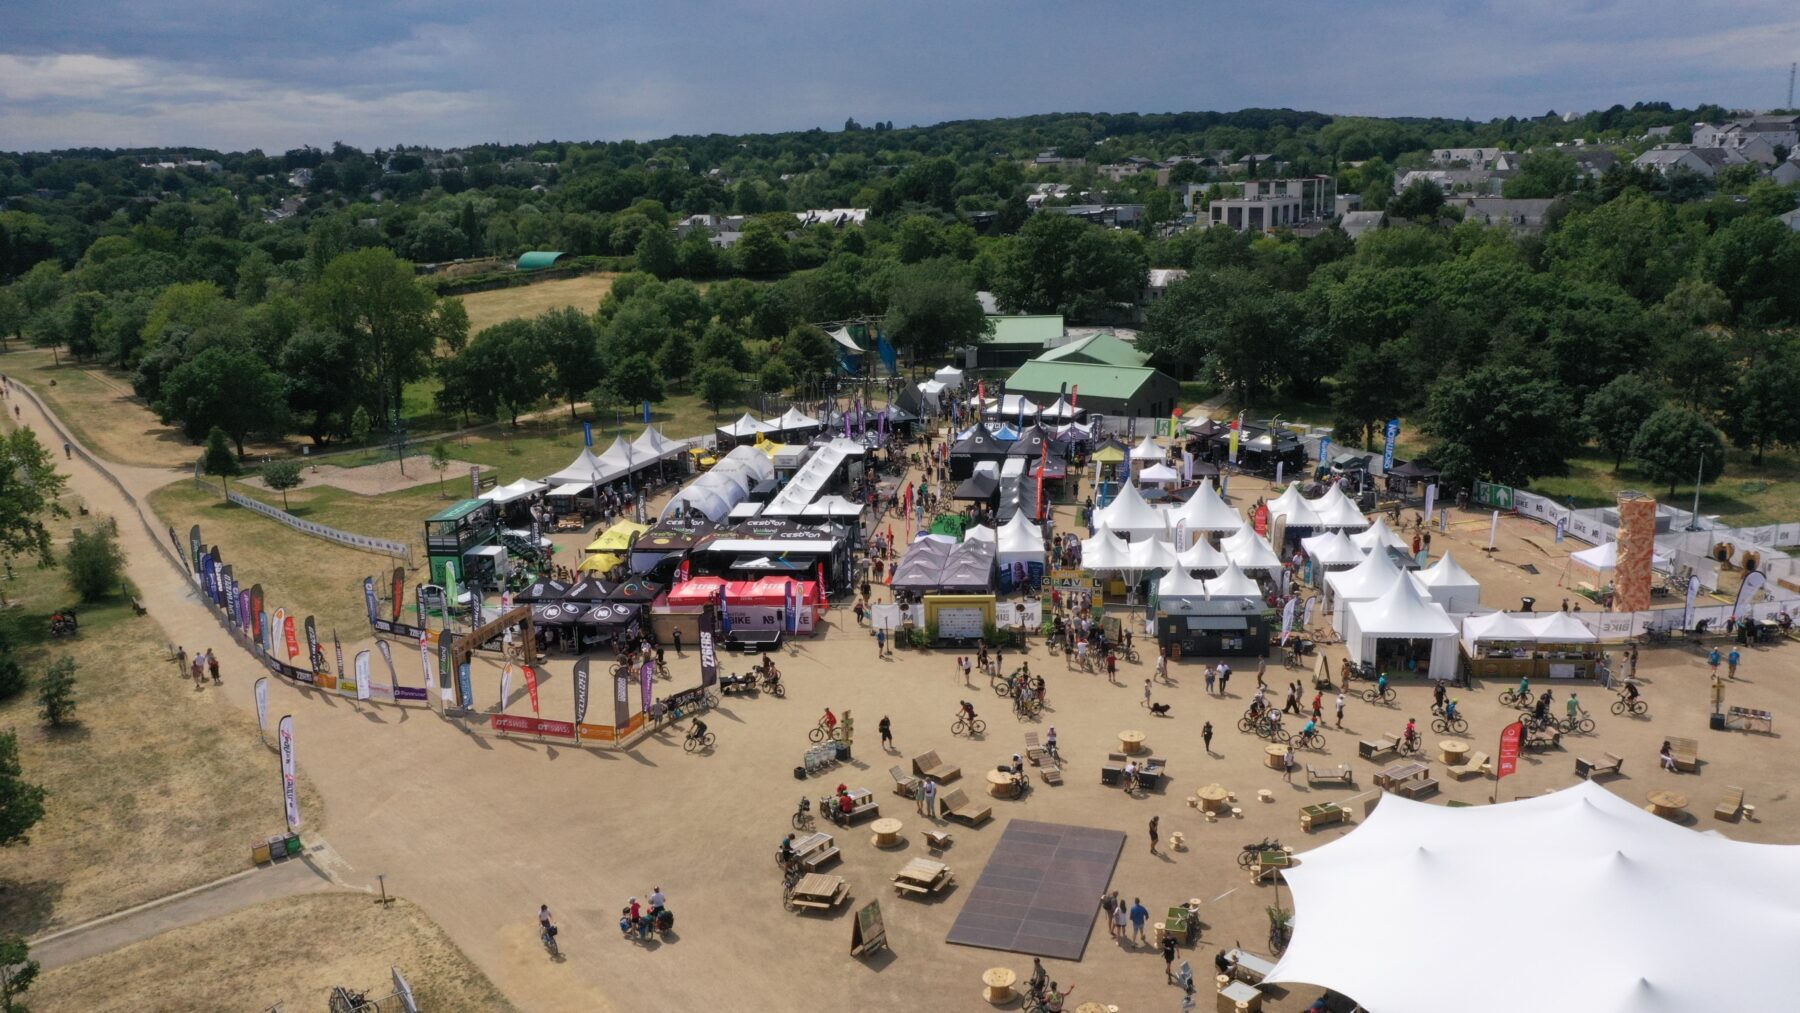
[0,103,1800,496]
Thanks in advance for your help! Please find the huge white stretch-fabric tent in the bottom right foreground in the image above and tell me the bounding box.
[1269,781,1800,1013]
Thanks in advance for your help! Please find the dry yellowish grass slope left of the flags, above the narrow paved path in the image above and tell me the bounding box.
[0,520,320,936]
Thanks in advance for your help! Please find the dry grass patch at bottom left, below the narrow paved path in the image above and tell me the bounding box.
[36,892,513,1013]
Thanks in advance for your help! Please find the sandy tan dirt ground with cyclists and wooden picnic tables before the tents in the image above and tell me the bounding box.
[14,383,1800,1011]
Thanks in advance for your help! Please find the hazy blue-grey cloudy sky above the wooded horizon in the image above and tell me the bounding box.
[0,0,1800,151]
